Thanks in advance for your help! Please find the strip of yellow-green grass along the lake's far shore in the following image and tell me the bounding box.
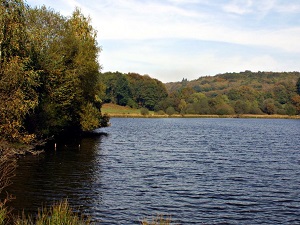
[101,103,300,119]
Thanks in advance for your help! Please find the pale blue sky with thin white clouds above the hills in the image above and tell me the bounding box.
[26,0,300,83]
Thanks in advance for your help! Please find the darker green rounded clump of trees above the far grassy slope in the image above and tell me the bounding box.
[101,72,168,110]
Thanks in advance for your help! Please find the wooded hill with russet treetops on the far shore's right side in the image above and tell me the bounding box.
[163,71,300,115]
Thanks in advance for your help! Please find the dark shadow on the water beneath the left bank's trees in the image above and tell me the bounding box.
[6,132,108,219]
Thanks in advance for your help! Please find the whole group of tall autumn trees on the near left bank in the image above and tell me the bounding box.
[0,0,108,143]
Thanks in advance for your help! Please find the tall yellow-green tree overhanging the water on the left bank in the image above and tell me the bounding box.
[27,7,108,136]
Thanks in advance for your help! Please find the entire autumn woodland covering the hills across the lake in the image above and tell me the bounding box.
[102,71,300,115]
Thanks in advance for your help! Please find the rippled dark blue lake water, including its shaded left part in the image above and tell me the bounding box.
[5,118,300,224]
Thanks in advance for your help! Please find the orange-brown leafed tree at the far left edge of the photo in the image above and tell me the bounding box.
[0,0,39,143]
